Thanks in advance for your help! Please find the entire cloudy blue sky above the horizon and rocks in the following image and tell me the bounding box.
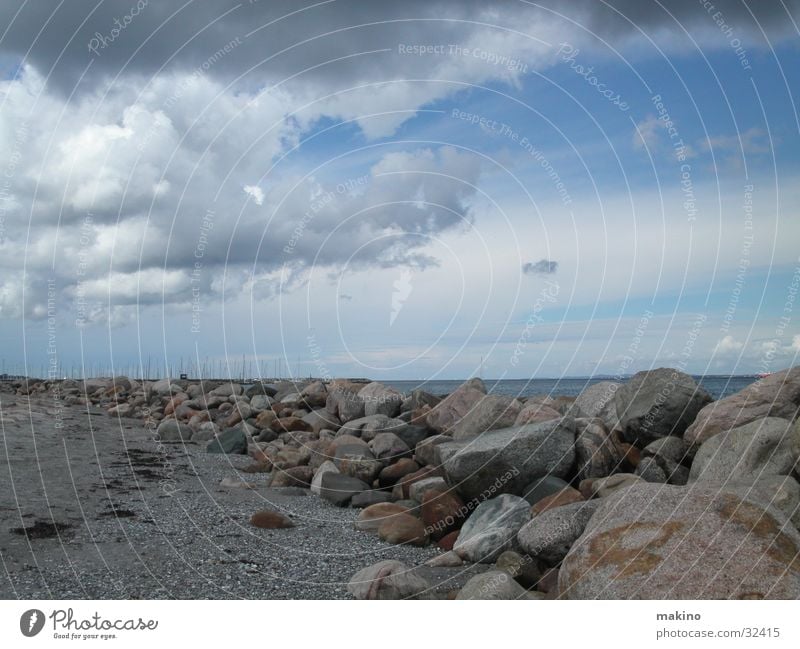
[0,0,800,379]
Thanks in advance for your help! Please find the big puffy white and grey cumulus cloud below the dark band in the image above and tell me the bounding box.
[0,58,480,322]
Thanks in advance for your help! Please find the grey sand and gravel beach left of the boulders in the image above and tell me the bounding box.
[0,394,484,599]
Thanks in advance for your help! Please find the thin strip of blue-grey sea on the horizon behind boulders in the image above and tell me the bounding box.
[381,375,758,400]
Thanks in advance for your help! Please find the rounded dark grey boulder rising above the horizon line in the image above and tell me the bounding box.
[614,368,711,448]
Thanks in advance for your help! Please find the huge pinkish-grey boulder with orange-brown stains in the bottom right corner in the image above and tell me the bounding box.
[559,483,800,599]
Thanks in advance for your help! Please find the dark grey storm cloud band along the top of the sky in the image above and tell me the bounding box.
[0,0,800,90]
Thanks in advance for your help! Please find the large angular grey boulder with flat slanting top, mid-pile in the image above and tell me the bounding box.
[435,417,575,502]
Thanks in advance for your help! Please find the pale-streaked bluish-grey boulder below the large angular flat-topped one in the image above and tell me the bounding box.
[453,494,531,563]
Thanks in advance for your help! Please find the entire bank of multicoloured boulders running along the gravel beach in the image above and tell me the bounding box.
[17,368,800,599]
